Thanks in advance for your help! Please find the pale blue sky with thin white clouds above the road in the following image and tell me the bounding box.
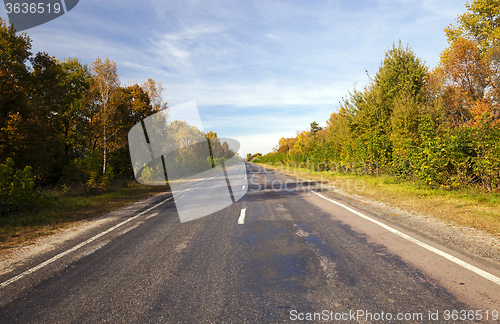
[0,0,466,156]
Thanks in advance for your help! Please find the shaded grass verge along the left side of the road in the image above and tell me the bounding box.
[0,181,169,255]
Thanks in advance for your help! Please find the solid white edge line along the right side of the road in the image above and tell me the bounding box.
[311,191,500,285]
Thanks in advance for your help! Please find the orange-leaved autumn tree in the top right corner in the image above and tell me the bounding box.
[440,0,500,126]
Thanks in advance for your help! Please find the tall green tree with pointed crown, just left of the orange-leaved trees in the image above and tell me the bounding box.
[338,42,427,168]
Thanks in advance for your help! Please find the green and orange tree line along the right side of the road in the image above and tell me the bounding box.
[254,0,500,191]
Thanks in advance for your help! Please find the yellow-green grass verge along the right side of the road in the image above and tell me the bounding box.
[259,164,500,236]
